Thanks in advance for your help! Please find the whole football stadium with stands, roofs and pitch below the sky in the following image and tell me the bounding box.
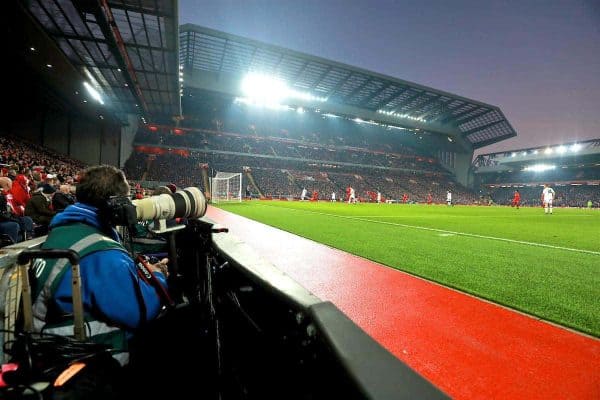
[0,0,600,400]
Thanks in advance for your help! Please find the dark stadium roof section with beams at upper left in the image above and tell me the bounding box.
[26,0,181,121]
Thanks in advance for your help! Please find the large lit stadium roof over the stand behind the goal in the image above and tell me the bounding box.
[179,24,517,148]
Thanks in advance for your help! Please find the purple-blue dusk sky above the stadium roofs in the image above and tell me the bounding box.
[179,0,600,153]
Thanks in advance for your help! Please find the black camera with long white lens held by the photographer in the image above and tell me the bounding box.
[103,187,207,226]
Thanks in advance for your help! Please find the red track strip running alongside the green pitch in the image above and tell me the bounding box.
[207,207,600,400]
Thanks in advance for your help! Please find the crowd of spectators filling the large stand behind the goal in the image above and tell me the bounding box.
[126,111,476,204]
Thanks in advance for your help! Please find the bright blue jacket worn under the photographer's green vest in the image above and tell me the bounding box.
[49,203,166,331]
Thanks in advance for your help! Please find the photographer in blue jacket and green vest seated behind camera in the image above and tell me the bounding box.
[32,165,168,364]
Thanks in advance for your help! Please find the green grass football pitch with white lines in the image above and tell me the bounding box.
[218,201,600,337]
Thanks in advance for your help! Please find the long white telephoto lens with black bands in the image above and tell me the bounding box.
[132,187,206,221]
